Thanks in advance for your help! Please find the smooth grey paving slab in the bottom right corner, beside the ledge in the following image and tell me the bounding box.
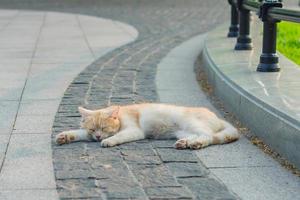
[212,166,300,200]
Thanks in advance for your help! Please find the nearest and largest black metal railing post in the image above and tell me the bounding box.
[256,0,282,72]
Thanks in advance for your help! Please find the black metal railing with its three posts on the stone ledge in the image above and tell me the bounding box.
[227,0,300,72]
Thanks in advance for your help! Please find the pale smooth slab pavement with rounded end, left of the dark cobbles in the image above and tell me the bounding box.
[0,10,137,199]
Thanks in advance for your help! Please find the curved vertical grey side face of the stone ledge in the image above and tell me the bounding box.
[202,27,300,168]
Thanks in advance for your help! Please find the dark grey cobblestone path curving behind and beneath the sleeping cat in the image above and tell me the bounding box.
[0,0,237,199]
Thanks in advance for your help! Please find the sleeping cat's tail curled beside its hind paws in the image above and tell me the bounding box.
[213,120,240,144]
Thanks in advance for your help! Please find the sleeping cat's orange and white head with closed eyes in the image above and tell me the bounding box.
[78,106,121,141]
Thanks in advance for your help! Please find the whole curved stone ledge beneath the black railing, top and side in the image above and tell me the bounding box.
[202,20,300,168]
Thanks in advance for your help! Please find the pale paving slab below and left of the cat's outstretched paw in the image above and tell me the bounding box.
[0,134,55,190]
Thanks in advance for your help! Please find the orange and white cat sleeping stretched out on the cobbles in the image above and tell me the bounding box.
[56,104,239,149]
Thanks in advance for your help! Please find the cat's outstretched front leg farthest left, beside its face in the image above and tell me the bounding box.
[55,129,92,145]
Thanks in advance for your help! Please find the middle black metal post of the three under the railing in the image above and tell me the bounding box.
[234,0,252,50]
